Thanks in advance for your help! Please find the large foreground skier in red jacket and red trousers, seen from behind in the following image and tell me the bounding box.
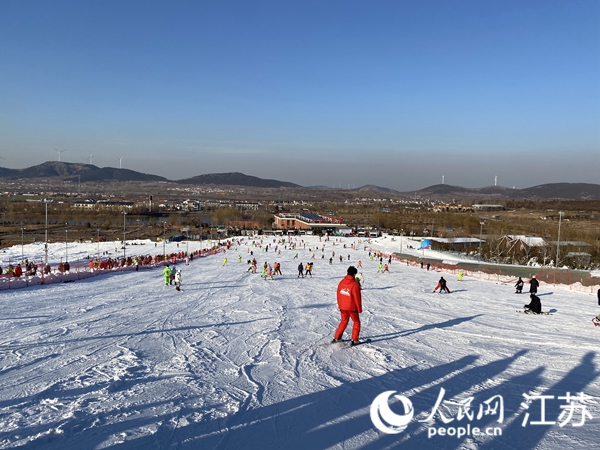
[332,266,362,345]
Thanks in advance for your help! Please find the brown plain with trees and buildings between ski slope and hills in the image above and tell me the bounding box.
[0,164,600,270]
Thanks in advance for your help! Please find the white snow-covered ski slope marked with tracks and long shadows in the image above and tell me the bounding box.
[0,236,600,449]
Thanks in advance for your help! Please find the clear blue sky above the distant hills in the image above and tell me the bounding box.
[0,0,600,191]
